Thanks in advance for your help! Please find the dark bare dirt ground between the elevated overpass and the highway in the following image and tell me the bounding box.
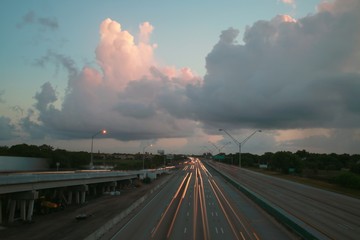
[0,176,169,240]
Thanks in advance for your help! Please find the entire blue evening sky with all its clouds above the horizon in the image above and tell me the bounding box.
[0,0,360,154]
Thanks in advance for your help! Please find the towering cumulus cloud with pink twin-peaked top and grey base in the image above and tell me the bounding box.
[26,19,200,140]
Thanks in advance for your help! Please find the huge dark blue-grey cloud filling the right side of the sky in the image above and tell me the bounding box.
[188,0,360,129]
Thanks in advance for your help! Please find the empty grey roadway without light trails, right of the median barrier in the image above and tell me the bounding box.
[209,159,360,240]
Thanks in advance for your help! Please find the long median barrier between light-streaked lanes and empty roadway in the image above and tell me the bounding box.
[207,164,321,240]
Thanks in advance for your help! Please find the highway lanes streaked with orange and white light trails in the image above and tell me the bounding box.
[111,159,296,240]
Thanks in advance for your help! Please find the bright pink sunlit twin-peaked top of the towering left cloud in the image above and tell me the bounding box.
[96,19,155,90]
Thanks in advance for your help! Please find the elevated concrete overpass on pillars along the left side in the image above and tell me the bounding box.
[0,168,169,224]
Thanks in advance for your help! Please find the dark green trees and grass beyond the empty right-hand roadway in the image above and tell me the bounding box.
[214,150,360,190]
